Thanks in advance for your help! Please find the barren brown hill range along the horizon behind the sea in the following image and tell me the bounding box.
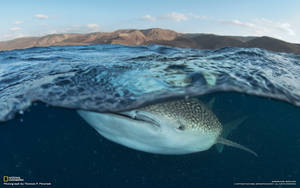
[0,28,300,54]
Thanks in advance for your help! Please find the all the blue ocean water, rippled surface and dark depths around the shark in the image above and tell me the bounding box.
[0,45,300,187]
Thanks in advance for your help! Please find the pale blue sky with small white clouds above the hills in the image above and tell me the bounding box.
[0,0,300,43]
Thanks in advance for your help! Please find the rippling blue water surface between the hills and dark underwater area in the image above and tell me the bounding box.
[0,45,300,121]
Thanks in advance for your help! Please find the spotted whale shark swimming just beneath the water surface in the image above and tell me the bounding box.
[78,99,257,156]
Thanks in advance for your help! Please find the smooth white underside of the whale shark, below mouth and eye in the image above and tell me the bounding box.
[78,110,216,154]
